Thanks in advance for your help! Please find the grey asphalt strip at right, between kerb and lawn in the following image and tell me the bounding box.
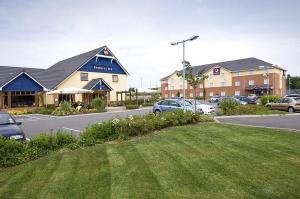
[217,114,300,131]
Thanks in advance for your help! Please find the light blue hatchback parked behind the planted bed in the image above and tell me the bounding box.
[152,99,203,114]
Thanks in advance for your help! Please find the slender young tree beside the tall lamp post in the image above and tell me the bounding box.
[177,61,208,112]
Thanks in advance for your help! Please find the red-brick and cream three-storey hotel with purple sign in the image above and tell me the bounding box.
[161,58,286,98]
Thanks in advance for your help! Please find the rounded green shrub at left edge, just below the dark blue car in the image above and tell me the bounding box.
[0,136,25,167]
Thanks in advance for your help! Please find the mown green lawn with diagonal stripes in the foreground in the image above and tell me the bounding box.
[0,123,300,199]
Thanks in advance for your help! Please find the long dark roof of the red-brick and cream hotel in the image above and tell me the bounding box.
[161,57,285,81]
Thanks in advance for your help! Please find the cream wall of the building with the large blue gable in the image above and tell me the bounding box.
[47,71,128,104]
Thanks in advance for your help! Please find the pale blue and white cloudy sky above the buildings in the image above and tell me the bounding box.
[0,0,300,88]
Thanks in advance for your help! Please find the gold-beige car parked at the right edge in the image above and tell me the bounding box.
[266,97,300,113]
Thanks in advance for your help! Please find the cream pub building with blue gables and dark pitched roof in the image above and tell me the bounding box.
[0,46,129,109]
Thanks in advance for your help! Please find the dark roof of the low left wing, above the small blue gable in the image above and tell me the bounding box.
[0,66,45,88]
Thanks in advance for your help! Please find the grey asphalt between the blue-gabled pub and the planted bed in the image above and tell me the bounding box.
[14,108,152,138]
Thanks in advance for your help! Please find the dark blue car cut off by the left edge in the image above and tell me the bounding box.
[0,111,26,141]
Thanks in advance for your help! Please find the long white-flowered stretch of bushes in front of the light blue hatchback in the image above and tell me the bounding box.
[80,110,213,144]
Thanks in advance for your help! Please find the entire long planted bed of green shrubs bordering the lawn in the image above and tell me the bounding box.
[0,110,213,167]
